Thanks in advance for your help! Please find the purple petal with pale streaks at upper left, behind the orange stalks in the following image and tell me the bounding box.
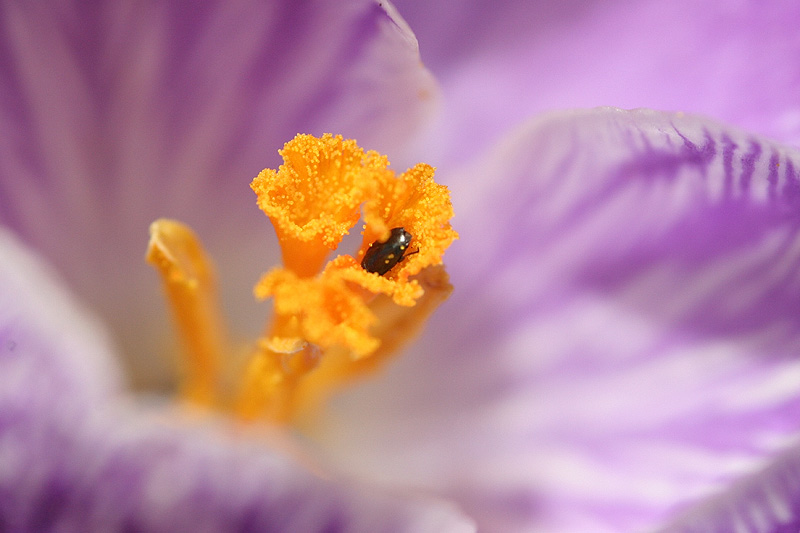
[0,0,437,386]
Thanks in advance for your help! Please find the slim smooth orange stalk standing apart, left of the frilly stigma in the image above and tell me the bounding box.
[147,219,223,406]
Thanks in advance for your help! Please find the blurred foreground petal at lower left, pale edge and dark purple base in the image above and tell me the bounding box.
[0,225,474,533]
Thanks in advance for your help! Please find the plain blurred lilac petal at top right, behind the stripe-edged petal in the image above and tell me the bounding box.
[396,0,800,166]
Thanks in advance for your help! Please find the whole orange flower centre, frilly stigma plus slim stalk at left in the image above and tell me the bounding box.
[147,134,458,425]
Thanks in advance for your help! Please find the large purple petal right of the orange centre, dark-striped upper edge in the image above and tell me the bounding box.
[316,108,800,532]
